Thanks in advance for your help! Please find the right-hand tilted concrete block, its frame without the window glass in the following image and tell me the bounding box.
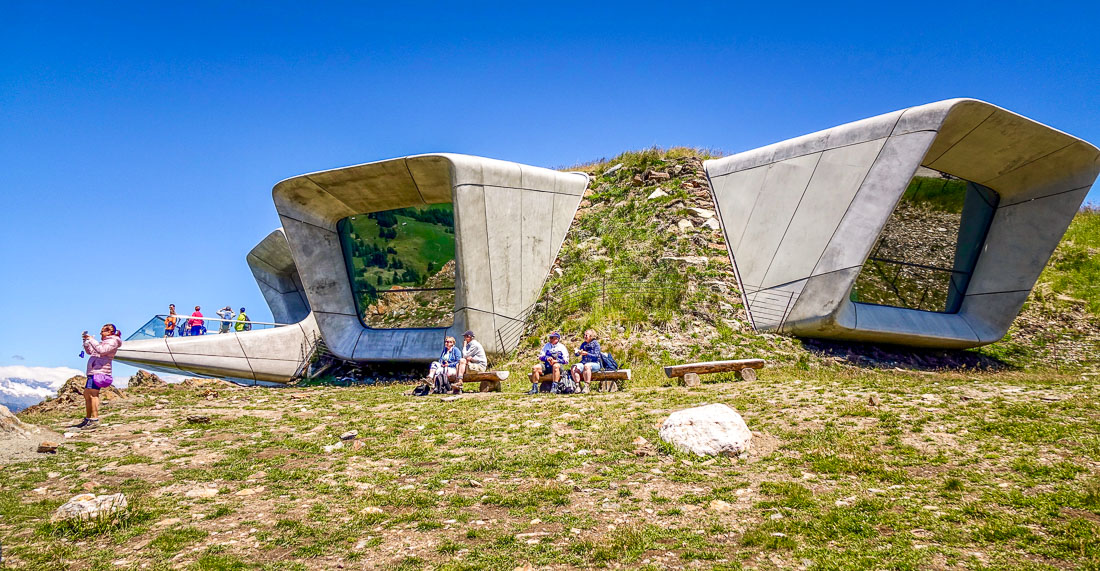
[704,99,1100,348]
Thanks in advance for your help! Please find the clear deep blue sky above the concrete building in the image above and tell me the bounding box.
[0,1,1100,378]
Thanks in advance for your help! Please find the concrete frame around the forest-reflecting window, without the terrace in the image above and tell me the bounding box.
[272,154,587,361]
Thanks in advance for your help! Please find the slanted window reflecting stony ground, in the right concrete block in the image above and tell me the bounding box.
[851,166,1000,314]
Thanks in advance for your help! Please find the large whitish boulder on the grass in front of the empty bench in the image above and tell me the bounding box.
[659,404,752,457]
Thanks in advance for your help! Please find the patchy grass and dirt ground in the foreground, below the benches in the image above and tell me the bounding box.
[8,366,1100,571]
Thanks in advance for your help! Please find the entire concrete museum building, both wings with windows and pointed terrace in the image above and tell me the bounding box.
[117,99,1100,382]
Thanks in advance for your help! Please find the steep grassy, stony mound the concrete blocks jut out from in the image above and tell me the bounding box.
[507,147,1100,384]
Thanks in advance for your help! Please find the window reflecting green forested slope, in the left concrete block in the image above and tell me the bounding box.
[337,204,454,329]
